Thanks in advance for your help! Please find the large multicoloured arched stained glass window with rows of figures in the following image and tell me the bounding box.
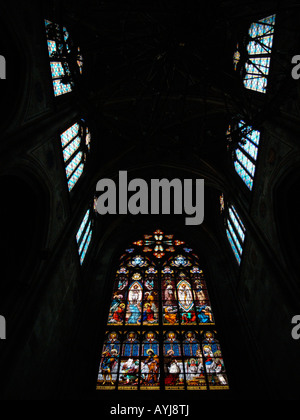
[97,230,229,391]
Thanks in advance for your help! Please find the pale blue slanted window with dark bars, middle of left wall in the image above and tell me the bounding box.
[60,119,91,191]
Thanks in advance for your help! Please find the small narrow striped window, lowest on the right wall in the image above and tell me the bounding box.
[226,205,246,265]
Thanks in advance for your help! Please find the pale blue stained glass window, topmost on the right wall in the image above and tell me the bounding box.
[244,15,276,93]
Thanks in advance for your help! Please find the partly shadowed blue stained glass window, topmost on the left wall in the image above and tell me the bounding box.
[45,20,83,96]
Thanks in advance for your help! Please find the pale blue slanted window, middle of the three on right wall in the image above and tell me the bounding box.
[227,121,260,191]
